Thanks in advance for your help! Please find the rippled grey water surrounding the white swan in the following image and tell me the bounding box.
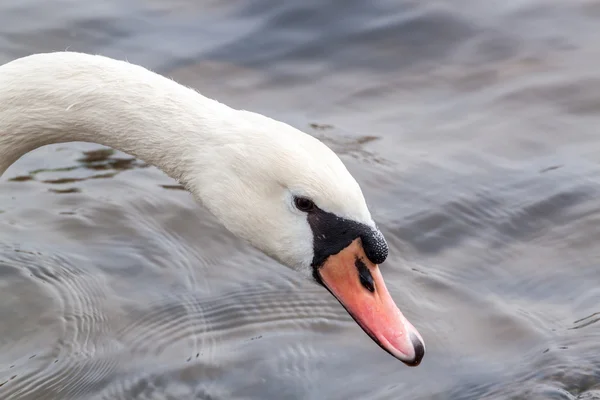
[0,0,600,400]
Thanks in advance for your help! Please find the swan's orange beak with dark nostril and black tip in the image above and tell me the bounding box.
[317,239,425,366]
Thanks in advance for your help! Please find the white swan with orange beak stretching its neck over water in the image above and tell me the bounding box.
[0,51,425,366]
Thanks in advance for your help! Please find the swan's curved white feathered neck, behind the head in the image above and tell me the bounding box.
[0,52,241,184]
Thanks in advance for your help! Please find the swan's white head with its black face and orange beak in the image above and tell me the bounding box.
[184,110,425,366]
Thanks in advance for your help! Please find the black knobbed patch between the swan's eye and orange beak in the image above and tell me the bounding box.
[307,206,388,269]
